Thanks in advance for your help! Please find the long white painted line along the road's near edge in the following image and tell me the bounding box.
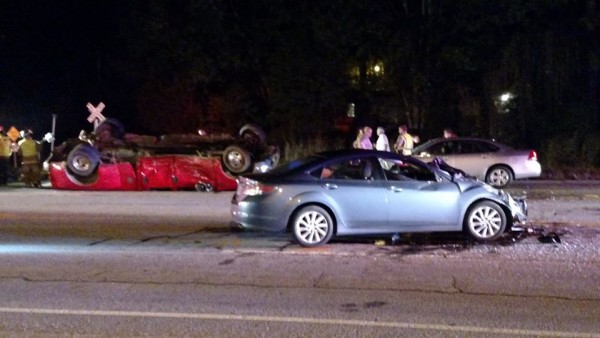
[0,307,600,338]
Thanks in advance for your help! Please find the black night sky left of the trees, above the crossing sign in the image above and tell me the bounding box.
[0,0,128,139]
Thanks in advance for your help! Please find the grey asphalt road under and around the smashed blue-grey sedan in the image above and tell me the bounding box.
[0,182,600,337]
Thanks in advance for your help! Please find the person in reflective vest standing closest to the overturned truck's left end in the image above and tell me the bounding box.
[19,130,42,188]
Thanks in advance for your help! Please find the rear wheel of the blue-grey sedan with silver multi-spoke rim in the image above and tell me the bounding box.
[292,205,333,247]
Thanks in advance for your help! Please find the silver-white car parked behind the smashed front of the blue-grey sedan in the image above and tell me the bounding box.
[413,137,542,188]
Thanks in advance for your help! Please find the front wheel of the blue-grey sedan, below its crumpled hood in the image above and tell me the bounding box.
[464,201,506,242]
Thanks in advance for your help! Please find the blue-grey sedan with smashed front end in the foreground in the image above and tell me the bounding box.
[231,149,527,247]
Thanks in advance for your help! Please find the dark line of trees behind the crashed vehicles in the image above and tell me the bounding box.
[2,0,600,165]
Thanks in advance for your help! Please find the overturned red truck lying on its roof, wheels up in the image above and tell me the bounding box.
[48,118,279,191]
